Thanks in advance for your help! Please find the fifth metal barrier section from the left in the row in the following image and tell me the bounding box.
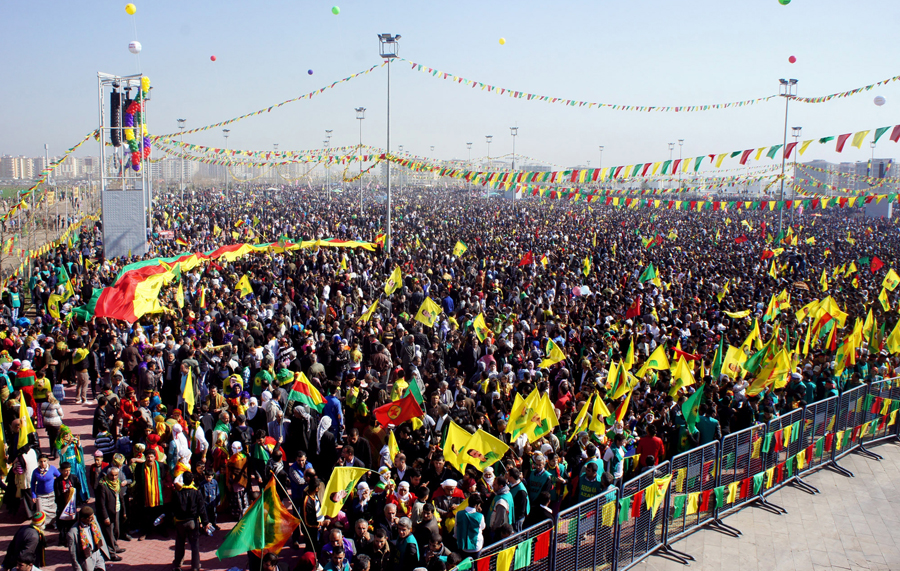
[715,424,767,519]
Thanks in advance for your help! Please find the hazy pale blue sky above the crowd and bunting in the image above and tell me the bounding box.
[0,0,900,170]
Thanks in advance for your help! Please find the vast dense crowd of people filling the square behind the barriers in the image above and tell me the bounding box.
[0,184,900,571]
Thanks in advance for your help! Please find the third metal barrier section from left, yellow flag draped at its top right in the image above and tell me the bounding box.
[616,462,671,570]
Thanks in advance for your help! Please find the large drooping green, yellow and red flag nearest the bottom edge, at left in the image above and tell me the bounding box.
[216,478,300,559]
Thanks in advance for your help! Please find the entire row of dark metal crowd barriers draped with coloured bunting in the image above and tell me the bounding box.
[455,377,900,571]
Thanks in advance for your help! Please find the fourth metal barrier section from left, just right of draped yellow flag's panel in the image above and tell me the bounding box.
[666,441,720,543]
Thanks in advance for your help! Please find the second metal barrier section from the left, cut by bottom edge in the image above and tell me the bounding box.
[553,489,620,571]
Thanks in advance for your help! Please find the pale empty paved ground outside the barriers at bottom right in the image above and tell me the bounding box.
[635,443,900,571]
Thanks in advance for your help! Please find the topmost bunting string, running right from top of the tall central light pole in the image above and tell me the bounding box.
[398,58,900,113]
